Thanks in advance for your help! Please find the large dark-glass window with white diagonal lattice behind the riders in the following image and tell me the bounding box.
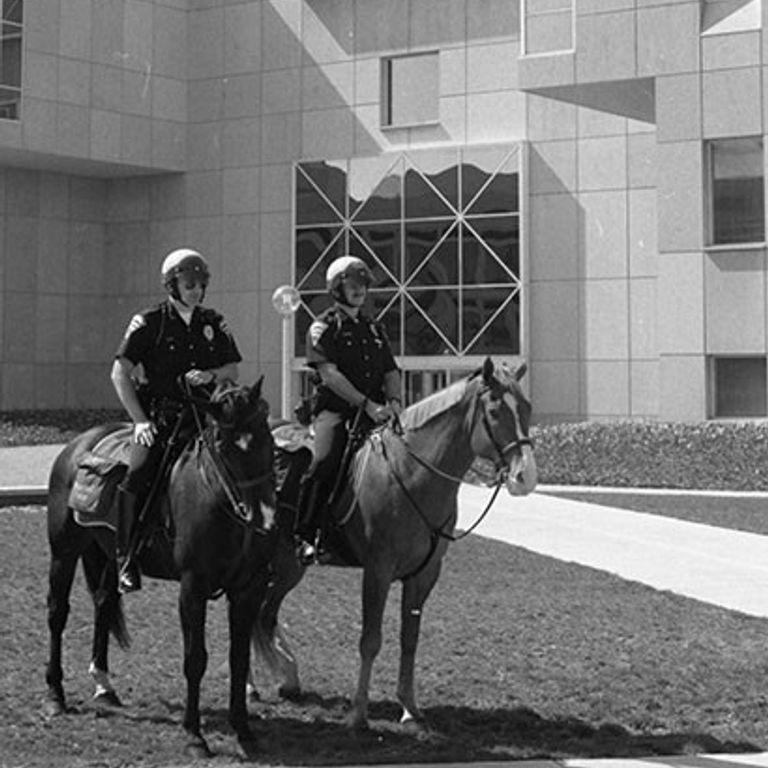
[294,146,522,372]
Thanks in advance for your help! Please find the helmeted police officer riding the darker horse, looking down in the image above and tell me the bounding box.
[111,248,242,593]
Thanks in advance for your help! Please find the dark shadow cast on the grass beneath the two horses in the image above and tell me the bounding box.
[121,693,760,766]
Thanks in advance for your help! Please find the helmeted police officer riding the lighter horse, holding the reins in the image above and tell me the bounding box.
[298,255,401,564]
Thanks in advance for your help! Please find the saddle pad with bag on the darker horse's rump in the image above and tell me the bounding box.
[69,427,132,529]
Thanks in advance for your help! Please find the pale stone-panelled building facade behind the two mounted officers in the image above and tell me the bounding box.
[0,0,768,421]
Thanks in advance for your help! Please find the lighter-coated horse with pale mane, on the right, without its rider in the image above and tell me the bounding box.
[253,358,536,728]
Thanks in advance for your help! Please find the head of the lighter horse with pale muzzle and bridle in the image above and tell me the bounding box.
[464,357,536,496]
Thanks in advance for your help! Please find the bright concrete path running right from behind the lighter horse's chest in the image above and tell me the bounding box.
[459,485,768,617]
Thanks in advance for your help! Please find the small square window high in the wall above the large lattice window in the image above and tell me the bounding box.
[381,52,440,128]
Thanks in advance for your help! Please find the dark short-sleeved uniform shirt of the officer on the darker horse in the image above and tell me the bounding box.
[116,300,242,401]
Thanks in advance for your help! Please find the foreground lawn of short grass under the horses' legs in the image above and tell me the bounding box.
[0,507,768,768]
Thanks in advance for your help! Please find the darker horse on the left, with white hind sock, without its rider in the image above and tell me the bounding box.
[46,379,275,755]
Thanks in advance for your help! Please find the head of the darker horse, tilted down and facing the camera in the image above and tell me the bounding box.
[204,376,276,529]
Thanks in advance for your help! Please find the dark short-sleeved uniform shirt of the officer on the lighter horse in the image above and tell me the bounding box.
[307,307,398,414]
